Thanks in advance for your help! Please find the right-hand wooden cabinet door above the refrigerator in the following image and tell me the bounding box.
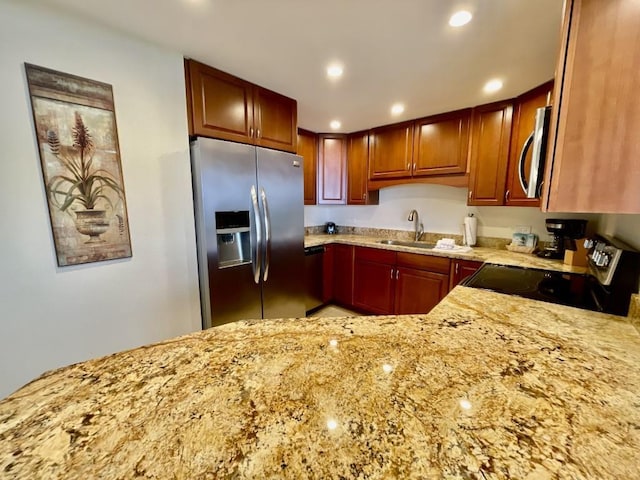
[254,87,298,153]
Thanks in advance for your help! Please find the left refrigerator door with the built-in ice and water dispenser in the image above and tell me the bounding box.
[191,138,262,328]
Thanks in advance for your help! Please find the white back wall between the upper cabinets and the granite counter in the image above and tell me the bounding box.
[304,184,599,240]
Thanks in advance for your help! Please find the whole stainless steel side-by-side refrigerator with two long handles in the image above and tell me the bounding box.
[191,138,305,328]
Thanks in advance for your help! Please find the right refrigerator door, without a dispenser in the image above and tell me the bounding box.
[257,148,305,318]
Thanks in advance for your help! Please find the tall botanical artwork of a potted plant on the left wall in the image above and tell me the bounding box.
[25,64,131,266]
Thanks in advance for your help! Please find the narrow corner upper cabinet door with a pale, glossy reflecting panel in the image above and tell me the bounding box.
[317,134,347,205]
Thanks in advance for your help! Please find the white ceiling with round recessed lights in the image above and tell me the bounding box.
[31,0,562,132]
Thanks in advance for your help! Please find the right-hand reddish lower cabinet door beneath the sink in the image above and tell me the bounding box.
[395,267,449,315]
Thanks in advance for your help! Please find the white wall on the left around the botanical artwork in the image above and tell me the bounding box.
[0,2,200,398]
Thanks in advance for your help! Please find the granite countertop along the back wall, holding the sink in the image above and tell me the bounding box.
[304,234,587,274]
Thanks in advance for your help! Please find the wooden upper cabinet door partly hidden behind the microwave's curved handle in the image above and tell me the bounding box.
[505,81,553,207]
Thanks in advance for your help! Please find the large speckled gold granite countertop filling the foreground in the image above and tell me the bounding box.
[0,287,640,480]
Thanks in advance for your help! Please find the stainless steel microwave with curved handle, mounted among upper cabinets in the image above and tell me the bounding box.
[518,106,551,198]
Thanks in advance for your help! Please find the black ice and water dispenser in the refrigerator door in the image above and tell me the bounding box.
[216,210,251,268]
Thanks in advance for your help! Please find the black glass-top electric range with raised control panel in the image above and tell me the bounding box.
[463,235,640,315]
